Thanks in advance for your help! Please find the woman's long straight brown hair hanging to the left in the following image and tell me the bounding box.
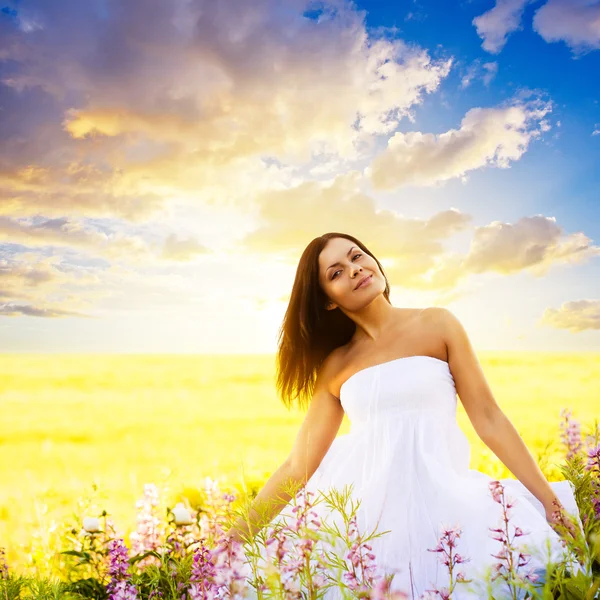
[276,232,391,408]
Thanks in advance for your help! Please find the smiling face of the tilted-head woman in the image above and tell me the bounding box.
[319,238,385,309]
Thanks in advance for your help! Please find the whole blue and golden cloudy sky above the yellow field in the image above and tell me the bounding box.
[0,0,600,354]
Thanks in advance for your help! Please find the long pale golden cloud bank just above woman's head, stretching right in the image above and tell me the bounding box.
[240,173,600,293]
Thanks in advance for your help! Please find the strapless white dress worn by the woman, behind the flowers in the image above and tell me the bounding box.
[241,355,580,599]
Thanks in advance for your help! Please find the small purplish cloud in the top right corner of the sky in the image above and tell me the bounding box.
[533,0,600,54]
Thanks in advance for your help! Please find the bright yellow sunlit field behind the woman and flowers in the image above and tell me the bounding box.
[0,353,600,572]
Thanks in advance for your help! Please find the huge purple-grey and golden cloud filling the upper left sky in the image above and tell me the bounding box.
[0,0,451,221]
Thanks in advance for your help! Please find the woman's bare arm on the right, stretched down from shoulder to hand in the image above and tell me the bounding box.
[438,308,564,521]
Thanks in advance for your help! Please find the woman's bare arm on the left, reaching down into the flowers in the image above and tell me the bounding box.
[227,351,344,542]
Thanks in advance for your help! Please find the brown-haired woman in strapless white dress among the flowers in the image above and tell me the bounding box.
[223,233,576,598]
